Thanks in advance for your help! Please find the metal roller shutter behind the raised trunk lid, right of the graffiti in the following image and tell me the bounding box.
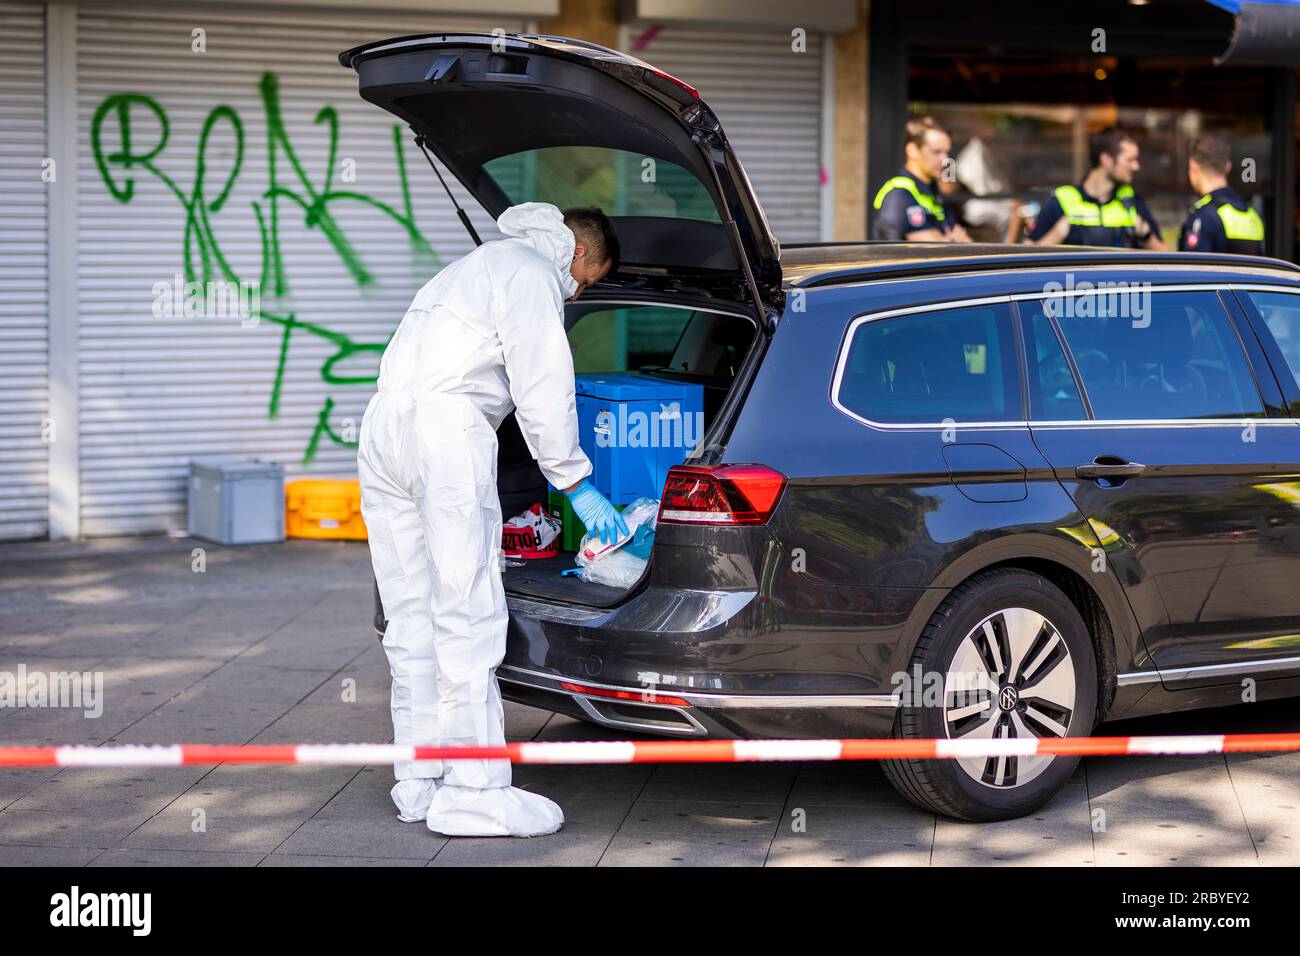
[628,25,822,242]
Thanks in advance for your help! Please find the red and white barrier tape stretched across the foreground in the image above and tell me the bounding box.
[0,734,1300,767]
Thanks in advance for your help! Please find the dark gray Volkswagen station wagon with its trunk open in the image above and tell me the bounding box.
[341,35,1300,819]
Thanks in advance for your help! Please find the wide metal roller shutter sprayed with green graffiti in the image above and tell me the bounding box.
[77,4,523,535]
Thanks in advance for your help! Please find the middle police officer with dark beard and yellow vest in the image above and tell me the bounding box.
[1026,126,1167,250]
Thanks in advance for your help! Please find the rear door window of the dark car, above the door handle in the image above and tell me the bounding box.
[1021,290,1265,421]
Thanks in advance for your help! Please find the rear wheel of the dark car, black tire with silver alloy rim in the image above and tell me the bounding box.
[881,568,1099,821]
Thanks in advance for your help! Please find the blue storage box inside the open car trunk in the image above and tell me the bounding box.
[559,372,705,505]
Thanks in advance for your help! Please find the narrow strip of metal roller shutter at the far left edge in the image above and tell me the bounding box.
[0,3,47,538]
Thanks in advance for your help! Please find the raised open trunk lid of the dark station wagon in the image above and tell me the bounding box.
[339,34,781,314]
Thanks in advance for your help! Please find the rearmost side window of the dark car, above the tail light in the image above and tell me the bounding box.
[836,303,1023,424]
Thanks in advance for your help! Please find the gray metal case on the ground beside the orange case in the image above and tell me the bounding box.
[190,458,285,545]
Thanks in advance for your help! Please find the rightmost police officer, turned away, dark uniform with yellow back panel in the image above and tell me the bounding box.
[1178,134,1264,256]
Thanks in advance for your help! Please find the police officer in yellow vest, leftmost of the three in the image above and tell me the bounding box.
[871,116,971,242]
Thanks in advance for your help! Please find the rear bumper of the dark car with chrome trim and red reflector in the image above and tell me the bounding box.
[497,589,896,737]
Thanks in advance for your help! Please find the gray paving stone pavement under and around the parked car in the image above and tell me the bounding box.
[0,536,1300,866]
